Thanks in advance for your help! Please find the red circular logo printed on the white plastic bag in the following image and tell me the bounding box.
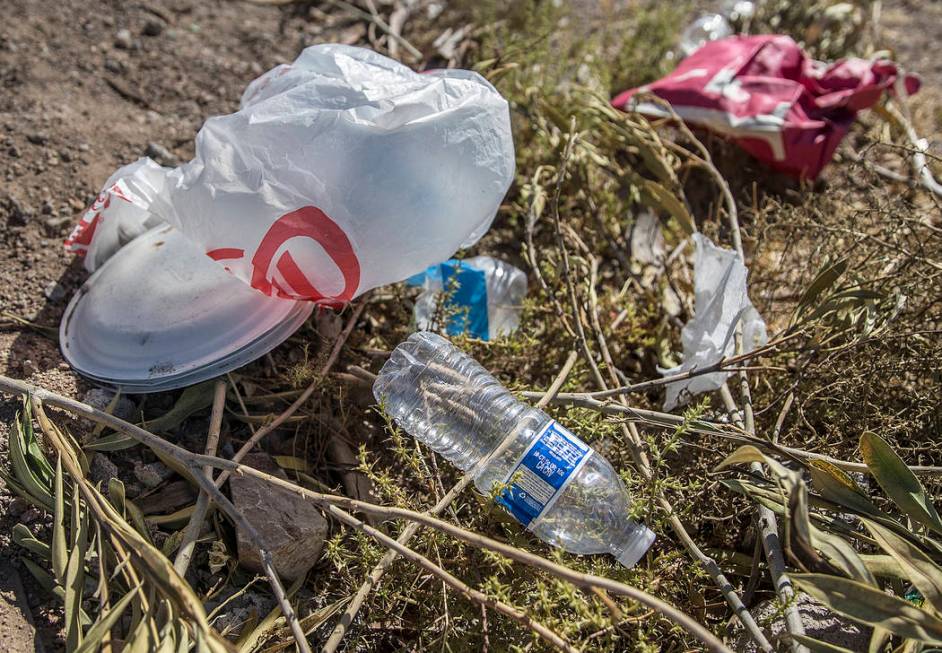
[251,206,360,303]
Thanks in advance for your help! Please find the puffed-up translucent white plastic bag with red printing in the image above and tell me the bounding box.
[66,45,514,304]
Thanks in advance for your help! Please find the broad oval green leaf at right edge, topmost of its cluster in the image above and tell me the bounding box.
[860,431,942,534]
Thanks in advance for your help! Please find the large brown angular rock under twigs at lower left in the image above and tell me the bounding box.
[229,453,328,581]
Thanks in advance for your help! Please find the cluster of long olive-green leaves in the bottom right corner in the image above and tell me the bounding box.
[719,432,942,651]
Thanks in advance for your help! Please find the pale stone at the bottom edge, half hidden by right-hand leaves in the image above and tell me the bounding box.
[734,593,873,653]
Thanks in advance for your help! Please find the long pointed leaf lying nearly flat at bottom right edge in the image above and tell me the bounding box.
[790,574,942,644]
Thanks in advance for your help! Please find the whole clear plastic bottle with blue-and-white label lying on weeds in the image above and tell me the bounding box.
[373,331,654,567]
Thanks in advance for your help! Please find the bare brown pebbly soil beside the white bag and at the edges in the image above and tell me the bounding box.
[0,0,942,651]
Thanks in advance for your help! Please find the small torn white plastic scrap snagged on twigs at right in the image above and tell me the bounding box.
[658,233,768,410]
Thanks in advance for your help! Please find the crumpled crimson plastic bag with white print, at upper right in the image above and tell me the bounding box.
[612,35,919,179]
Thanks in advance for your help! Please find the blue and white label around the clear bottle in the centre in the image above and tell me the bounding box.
[497,420,592,529]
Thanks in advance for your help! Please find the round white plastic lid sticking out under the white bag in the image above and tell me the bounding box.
[59,226,314,393]
